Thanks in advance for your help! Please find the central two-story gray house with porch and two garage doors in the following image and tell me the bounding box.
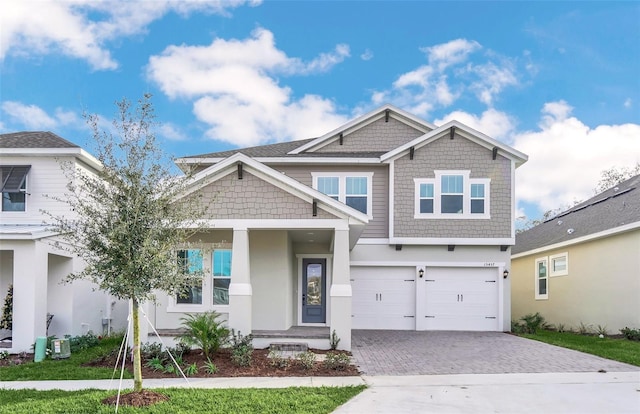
[148,105,527,350]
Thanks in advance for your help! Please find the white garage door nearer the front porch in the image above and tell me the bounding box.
[351,266,416,330]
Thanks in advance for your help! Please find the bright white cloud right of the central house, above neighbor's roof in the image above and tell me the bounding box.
[513,101,640,212]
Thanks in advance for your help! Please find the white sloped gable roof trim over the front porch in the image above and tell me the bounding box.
[180,153,369,225]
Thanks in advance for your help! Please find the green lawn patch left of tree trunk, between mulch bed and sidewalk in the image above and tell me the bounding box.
[0,337,132,381]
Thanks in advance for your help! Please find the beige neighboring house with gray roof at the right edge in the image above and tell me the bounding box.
[511,175,640,333]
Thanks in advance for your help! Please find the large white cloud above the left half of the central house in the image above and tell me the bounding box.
[147,28,350,146]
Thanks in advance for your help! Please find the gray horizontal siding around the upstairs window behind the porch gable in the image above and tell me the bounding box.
[272,165,389,238]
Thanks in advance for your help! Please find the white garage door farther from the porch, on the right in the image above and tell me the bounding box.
[419,267,499,331]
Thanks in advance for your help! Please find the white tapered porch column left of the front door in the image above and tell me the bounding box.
[229,228,252,335]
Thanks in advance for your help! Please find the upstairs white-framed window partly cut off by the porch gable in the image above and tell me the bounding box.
[311,172,373,218]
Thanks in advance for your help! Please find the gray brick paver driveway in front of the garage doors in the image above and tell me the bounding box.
[351,330,640,375]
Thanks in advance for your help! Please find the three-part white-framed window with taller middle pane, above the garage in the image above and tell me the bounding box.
[414,170,491,219]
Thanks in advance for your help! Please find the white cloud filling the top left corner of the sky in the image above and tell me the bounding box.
[0,0,259,70]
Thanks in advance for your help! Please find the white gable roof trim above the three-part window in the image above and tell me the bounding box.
[380,121,529,168]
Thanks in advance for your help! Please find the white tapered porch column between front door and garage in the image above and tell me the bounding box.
[329,229,351,351]
